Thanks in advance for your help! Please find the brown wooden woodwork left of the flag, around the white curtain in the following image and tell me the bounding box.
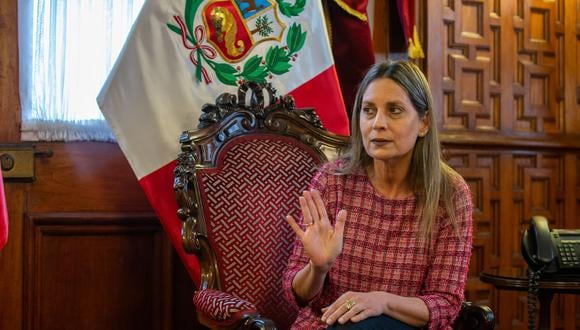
[0,0,197,329]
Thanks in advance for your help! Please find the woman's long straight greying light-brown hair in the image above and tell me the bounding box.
[338,61,459,242]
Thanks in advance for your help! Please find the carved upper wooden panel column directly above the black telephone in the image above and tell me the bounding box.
[506,0,566,133]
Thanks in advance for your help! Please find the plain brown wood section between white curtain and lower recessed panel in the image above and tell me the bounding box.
[28,142,151,213]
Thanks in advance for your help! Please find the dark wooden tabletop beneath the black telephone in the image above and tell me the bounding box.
[479,268,580,293]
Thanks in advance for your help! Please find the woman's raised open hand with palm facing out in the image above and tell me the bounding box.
[286,190,346,272]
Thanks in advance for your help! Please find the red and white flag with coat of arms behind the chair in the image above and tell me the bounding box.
[97,0,349,283]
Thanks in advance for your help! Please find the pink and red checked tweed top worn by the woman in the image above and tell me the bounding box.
[283,163,473,329]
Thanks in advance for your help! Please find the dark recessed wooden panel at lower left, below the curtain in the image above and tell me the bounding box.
[24,213,171,330]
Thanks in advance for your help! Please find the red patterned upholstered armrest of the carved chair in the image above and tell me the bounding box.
[193,289,276,330]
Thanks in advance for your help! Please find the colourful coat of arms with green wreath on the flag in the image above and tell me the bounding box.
[167,0,307,86]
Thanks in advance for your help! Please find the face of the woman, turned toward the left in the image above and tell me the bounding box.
[360,78,428,165]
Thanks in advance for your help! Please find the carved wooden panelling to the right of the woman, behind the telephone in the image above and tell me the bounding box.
[420,0,580,329]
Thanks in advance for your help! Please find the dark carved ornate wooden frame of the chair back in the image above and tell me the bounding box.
[174,82,348,328]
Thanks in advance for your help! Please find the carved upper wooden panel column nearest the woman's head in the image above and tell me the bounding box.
[440,1,501,132]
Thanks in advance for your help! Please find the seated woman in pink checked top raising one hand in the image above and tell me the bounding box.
[283,62,472,329]
